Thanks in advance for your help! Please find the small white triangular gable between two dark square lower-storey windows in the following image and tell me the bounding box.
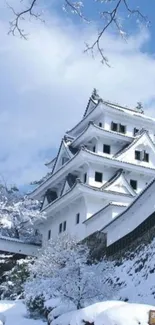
[101,169,136,196]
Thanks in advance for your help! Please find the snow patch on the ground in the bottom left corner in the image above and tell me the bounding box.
[0,300,45,325]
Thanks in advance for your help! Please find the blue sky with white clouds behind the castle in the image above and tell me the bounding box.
[0,0,155,186]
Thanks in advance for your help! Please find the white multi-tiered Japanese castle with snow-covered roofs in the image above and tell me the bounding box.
[31,90,155,252]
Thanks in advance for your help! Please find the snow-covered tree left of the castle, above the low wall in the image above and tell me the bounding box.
[0,185,45,242]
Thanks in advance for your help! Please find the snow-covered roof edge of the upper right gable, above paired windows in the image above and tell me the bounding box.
[114,129,155,158]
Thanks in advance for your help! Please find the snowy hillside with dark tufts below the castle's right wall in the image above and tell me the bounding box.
[114,228,155,304]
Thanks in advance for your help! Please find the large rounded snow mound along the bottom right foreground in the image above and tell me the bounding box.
[51,301,155,325]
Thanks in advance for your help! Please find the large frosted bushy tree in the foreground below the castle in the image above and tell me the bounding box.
[25,235,114,309]
